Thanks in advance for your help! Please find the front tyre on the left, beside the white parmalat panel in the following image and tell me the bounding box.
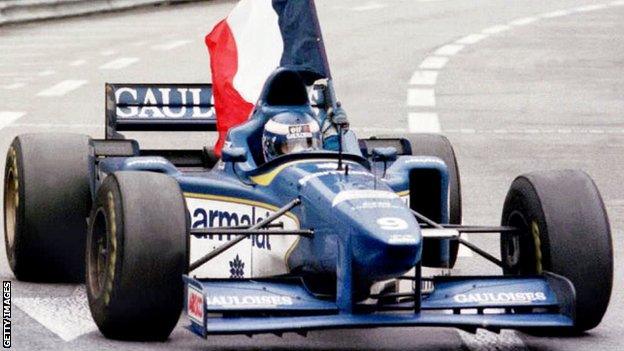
[86,172,189,341]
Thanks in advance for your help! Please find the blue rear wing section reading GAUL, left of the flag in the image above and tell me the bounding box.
[106,84,217,139]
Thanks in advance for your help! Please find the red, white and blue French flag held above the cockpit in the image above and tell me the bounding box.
[206,0,330,156]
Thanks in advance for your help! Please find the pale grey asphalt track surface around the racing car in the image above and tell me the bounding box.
[0,0,624,350]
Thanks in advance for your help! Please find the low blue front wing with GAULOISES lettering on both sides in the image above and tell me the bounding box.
[184,273,575,337]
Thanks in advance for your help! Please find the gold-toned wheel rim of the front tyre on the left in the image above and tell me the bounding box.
[88,208,109,296]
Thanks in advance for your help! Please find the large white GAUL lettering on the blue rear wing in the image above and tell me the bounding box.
[115,87,214,118]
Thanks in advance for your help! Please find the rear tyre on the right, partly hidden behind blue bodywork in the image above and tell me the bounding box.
[404,133,462,268]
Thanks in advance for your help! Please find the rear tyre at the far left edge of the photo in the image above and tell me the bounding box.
[4,133,93,282]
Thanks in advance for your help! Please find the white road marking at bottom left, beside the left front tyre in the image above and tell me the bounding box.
[13,286,97,341]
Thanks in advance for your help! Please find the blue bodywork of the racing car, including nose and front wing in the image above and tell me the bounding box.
[98,71,575,337]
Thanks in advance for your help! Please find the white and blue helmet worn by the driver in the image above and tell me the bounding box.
[262,112,321,161]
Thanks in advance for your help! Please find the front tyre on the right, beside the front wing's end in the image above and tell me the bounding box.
[501,170,613,332]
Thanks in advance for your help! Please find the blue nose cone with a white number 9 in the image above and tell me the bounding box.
[332,190,422,281]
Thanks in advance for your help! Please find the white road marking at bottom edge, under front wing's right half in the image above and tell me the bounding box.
[458,329,528,351]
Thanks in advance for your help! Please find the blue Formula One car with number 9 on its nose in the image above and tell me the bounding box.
[4,69,613,340]
